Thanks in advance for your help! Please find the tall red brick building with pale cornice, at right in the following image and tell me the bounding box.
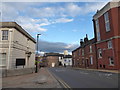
[93,1,120,69]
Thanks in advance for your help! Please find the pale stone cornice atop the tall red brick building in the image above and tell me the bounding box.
[93,1,120,20]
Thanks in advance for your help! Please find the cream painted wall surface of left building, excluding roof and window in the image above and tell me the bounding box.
[0,28,35,69]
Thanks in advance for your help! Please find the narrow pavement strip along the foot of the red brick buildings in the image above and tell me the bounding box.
[73,67,120,73]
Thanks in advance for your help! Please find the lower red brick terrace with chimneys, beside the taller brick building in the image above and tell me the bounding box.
[72,35,96,68]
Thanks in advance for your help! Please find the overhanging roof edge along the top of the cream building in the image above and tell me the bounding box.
[0,22,36,43]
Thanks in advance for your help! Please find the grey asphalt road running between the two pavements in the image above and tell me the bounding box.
[48,68,118,88]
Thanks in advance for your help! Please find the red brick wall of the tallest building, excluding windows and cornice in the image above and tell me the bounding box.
[94,2,120,69]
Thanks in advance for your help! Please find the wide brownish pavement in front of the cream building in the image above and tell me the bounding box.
[2,68,62,88]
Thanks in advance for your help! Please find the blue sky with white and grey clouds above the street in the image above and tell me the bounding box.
[0,0,110,52]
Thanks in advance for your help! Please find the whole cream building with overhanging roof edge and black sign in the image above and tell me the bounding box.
[0,22,36,69]
